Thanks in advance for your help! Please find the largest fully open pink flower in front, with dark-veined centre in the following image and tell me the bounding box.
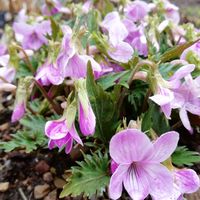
[109,129,179,200]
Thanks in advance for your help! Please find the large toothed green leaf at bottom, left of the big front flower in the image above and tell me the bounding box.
[60,152,110,198]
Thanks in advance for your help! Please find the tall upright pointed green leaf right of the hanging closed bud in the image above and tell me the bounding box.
[86,63,119,144]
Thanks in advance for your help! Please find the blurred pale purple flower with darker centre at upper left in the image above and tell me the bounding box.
[13,21,51,51]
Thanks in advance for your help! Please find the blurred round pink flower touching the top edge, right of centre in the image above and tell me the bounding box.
[125,0,149,22]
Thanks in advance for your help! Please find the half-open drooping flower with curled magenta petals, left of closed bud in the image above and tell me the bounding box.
[45,119,83,154]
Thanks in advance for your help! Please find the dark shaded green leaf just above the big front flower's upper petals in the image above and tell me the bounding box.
[142,102,170,135]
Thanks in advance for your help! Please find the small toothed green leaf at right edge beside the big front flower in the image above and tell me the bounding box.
[172,146,200,167]
